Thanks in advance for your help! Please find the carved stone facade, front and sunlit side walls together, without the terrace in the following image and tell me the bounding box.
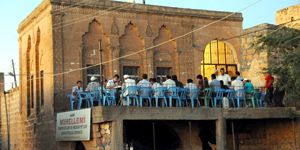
[16,0,242,149]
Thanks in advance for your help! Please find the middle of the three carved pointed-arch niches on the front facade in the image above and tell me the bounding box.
[119,22,147,77]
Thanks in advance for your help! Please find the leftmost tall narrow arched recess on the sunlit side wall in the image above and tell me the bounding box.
[26,35,31,115]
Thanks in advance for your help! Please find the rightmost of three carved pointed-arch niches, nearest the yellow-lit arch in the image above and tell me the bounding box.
[153,25,179,79]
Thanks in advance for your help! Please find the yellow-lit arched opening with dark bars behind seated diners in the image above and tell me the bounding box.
[201,40,238,78]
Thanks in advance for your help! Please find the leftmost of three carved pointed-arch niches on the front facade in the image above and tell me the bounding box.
[82,19,112,83]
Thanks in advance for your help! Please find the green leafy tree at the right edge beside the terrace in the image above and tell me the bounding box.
[252,26,300,103]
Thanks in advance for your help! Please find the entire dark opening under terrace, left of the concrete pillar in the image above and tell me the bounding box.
[123,120,216,150]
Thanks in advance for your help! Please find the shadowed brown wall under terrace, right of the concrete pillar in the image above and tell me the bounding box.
[227,119,299,150]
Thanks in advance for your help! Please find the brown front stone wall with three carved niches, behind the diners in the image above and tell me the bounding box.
[48,2,242,101]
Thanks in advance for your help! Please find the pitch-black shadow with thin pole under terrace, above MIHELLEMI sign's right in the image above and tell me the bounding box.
[124,121,181,150]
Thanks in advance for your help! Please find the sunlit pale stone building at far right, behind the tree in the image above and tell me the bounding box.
[240,5,300,87]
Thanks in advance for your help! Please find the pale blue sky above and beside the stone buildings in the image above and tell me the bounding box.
[0,0,300,90]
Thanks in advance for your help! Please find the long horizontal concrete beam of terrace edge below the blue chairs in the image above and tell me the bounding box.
[92,107,296,123]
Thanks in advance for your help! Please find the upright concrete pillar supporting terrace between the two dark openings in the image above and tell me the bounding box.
[216,117,227,150]
